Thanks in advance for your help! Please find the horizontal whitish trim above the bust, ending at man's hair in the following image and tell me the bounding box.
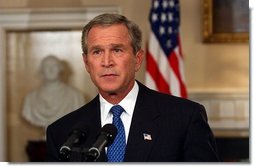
[0,7,121,29]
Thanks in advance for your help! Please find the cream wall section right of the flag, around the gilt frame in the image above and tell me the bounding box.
[181,0,249,92]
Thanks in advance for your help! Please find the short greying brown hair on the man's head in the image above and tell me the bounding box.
[81,13,142,55]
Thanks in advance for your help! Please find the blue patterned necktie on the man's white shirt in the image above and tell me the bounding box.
[107,105,126,162]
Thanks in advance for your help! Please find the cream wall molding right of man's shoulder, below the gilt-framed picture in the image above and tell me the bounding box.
[189,92,250,136]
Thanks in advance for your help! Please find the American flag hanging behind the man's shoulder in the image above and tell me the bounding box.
[145,0,187,98]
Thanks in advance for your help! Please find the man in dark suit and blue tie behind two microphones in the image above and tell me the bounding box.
[47,14,219,162]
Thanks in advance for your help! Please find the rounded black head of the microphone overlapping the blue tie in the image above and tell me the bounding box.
[101,124,117,146]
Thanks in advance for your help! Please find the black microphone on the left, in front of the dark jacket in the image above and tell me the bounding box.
[59,122,89,161]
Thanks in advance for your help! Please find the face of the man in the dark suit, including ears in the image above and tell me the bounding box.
[83,24,143,95]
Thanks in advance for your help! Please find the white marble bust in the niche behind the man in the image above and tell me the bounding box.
[22,56,85,128]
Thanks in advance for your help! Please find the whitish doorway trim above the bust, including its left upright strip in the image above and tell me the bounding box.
[0,7,121,161]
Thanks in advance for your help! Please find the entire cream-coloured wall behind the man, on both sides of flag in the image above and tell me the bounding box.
[0,0,249,92]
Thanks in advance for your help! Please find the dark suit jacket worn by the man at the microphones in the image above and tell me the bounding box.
[46,82,219,162]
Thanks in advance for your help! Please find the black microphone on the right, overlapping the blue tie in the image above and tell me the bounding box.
[86,124,117,162]
